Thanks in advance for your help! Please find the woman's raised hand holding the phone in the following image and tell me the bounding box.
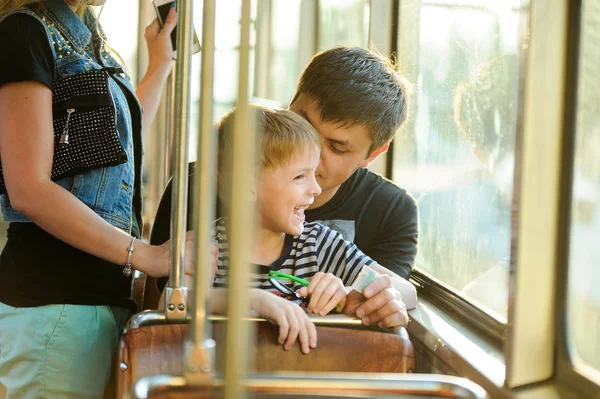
[144,7,177,77]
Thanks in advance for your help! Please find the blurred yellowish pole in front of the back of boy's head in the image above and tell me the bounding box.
[225,0,256,399]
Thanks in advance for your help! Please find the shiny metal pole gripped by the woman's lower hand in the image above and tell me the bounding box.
[165,0,193,321]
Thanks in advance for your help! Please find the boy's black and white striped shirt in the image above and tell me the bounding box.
[213,218,375,291]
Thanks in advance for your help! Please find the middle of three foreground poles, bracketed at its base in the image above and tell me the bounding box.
[184,0,218,384]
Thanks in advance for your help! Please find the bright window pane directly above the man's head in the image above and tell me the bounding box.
[318,0,369,51]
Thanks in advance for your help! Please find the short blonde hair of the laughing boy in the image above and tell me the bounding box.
[218,104,321,175]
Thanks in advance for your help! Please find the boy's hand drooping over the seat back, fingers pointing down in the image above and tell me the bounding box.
[250,289,317,353]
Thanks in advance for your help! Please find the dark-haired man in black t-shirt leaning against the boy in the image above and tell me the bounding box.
[151,47,418,326]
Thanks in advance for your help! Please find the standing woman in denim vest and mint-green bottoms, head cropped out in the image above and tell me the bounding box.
[0,0,191,398]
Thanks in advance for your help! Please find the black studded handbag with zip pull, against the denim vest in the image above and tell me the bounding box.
[0,68,127,194]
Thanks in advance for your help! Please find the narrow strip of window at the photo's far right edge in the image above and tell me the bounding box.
[567,0,600,383]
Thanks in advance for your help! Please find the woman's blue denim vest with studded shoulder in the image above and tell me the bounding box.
[0,0,143,233]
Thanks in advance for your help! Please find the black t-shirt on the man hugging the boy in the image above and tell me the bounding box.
[304,168,419,279]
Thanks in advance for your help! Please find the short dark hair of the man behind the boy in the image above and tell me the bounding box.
[292,47,409,154]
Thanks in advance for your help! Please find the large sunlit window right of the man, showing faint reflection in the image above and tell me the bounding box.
[392,0,520,322]
